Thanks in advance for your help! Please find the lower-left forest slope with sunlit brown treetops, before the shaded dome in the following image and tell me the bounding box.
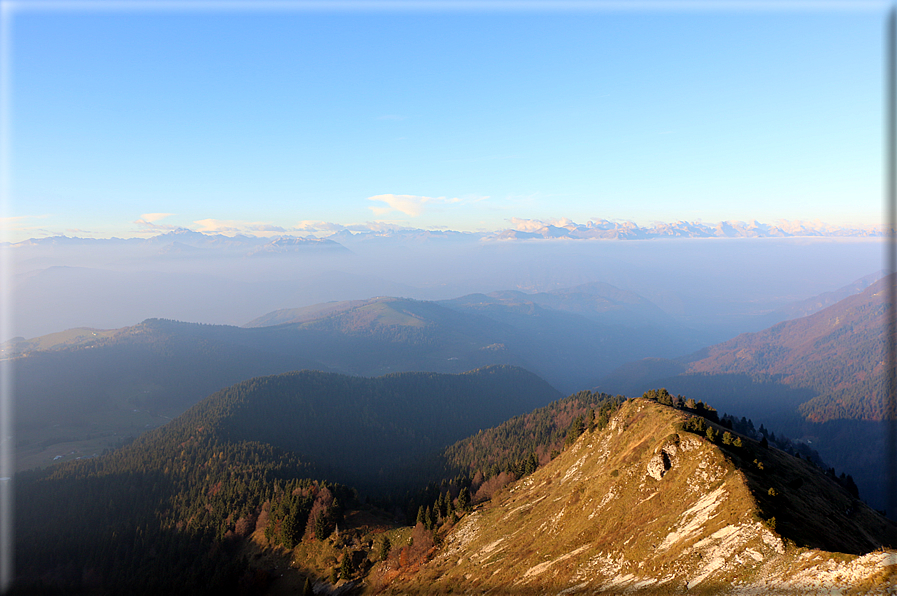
[16,426,355,595]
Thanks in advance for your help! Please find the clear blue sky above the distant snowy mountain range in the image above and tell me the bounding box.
[0,2,884,240]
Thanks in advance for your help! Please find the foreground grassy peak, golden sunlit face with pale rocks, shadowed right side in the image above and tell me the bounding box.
[371,398,897,594]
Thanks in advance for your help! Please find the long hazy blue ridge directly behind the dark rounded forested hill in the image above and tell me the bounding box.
[10,284,693,469]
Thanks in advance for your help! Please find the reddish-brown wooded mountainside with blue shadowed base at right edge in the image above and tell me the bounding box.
[598,276,894,508]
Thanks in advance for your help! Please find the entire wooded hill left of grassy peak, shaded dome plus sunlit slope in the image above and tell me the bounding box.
[16,367,558,594]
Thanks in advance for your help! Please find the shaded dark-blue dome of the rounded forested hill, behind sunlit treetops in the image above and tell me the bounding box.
[177,366,559,490]
